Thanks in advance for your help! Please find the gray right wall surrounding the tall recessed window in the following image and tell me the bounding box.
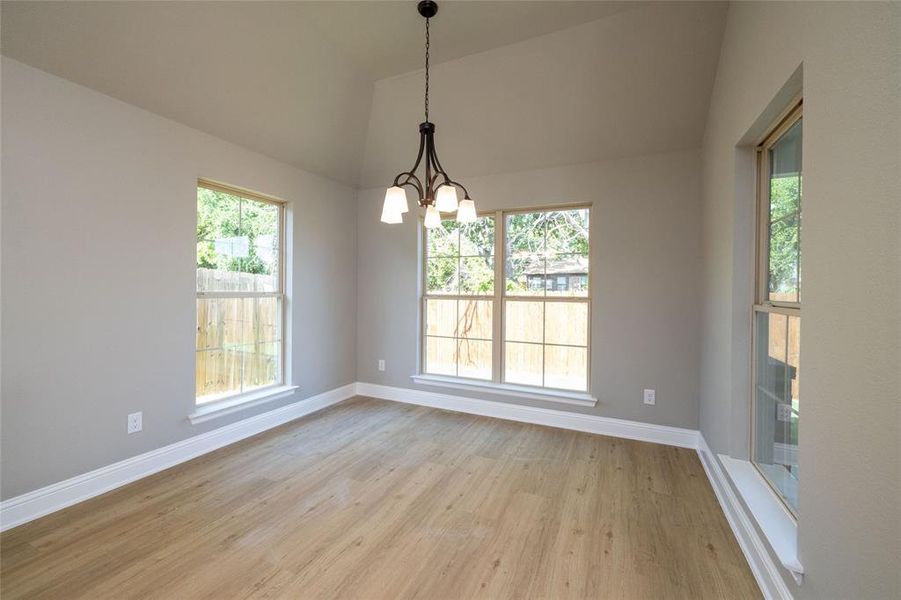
[700,2,901,598]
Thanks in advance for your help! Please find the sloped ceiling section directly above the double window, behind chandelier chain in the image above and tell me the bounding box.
[361,2,726,187]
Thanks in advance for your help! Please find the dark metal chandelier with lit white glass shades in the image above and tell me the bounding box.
[381,0,476,228]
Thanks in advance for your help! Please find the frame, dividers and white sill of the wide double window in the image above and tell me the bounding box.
[420,203,597,396]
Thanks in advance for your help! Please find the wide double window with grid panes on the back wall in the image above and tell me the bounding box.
[423,208,590,392]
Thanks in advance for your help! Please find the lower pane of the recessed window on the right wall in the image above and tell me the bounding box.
[754,312,800,509]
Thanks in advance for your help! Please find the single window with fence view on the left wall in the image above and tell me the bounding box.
[195,181,285,405]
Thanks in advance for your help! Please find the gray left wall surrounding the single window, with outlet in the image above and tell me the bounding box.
[0,58,356,498]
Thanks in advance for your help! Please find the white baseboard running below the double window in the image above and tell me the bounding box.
[357,382,698,449]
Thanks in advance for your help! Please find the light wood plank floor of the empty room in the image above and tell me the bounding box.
[0,398,760,600]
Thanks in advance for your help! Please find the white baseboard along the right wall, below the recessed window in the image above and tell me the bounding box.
[698,433,792,600]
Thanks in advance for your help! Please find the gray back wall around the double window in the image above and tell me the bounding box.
[357,151,701,428]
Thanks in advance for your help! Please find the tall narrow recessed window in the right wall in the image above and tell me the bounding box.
[752,104,802,512]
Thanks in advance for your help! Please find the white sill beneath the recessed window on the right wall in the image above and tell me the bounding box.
[719,454,804,584]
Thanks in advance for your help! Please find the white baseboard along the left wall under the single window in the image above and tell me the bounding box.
[0,383,356,531]
